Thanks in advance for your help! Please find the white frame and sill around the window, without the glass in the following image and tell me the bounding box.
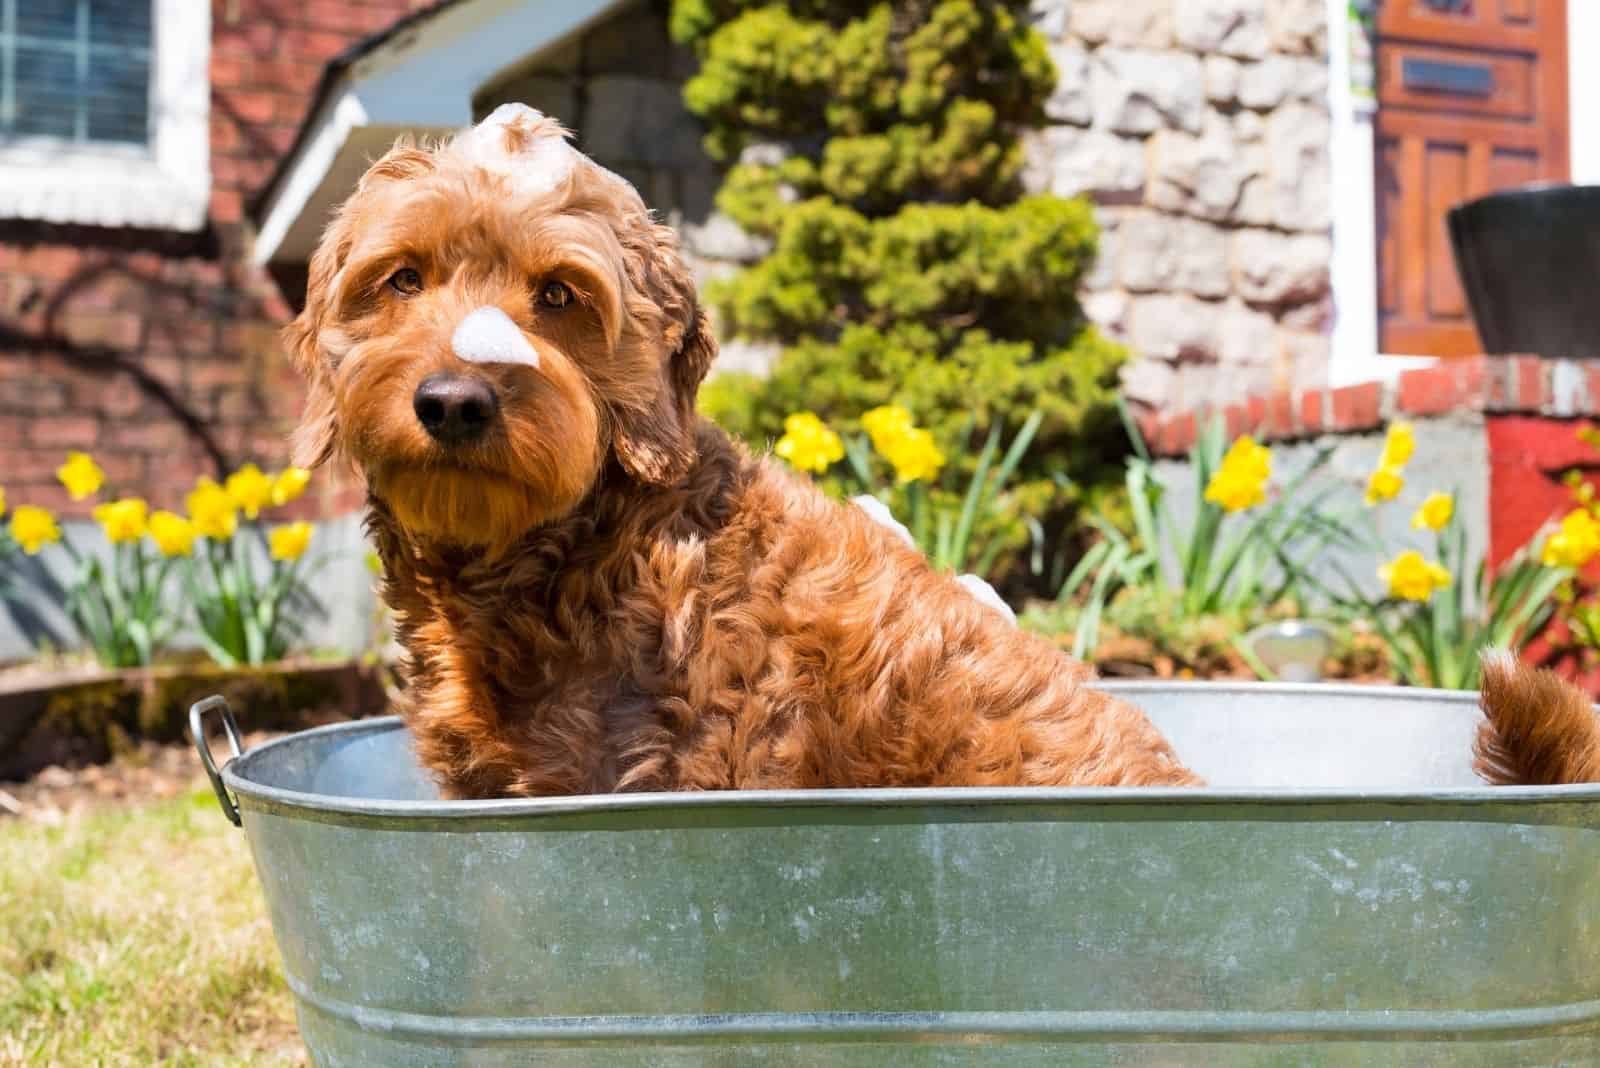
[0,0,211,230]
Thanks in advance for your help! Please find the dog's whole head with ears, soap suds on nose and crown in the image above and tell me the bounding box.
[286,104,715,548]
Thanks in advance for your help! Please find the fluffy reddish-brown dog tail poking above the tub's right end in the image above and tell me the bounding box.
[1472,649,1600,787]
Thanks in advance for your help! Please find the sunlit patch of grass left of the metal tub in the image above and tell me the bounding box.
[0,787,306,1066]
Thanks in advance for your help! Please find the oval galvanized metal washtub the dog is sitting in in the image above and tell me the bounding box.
[194,683,1600,1068]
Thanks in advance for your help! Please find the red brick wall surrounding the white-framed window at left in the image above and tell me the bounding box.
[0,0,429,515]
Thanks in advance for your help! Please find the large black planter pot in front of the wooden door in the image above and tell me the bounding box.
[1448,185,1600,358]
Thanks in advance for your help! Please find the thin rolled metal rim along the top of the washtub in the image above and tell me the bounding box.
[206,679,1600,831]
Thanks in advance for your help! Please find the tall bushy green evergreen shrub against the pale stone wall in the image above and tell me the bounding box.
[672,0,1126,591]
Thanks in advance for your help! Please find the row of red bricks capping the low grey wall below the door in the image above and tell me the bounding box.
[1139,357,1600,456]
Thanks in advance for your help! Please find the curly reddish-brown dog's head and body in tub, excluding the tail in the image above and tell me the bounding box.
[278,106,1198,798]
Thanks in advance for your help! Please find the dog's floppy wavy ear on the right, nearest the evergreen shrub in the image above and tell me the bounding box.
[613,227,717,486]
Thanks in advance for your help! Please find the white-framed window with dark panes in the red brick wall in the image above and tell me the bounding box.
[0,0,211,230]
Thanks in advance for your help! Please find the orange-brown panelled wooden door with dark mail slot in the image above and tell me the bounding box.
[1376,0,1568,357]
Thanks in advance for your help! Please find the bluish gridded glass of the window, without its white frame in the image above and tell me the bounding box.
[0,0,152,144]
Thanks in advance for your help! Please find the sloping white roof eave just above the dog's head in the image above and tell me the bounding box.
[253,0,624,264]
